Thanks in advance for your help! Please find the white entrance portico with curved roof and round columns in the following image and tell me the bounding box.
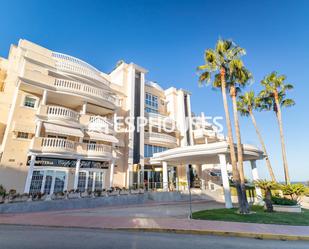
[151,141,264,208]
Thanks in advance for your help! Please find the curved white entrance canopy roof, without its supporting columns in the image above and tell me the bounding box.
[150,141,264,165]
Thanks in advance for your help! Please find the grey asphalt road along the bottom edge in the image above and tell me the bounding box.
[0,225,309,249]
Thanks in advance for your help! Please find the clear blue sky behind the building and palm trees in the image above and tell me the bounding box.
[0,0,309,181]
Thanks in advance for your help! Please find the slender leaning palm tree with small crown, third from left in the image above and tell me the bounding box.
[237,91,276,182]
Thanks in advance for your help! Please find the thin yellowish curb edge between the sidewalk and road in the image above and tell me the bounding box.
[0,223,309,241]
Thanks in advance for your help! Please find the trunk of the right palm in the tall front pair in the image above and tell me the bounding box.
[230,86,250,213]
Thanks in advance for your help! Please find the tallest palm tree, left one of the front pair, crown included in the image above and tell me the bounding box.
[198,39,249,213]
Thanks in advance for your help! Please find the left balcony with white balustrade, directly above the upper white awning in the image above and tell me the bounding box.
[39,105,80,123]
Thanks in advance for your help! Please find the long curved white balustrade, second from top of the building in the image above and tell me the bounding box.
[54,79,117,105]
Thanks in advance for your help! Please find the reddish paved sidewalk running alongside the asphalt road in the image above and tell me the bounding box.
[0,201,309,240]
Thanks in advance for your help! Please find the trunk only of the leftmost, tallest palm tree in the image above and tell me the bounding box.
[220,68,243,211]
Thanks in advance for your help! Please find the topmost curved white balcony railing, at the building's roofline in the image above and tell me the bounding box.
[52,52,109,85]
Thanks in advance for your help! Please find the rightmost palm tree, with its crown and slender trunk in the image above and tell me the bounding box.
[260,72,295,184]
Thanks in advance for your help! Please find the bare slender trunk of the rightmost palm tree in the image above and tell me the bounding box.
[274,91,290,184]
